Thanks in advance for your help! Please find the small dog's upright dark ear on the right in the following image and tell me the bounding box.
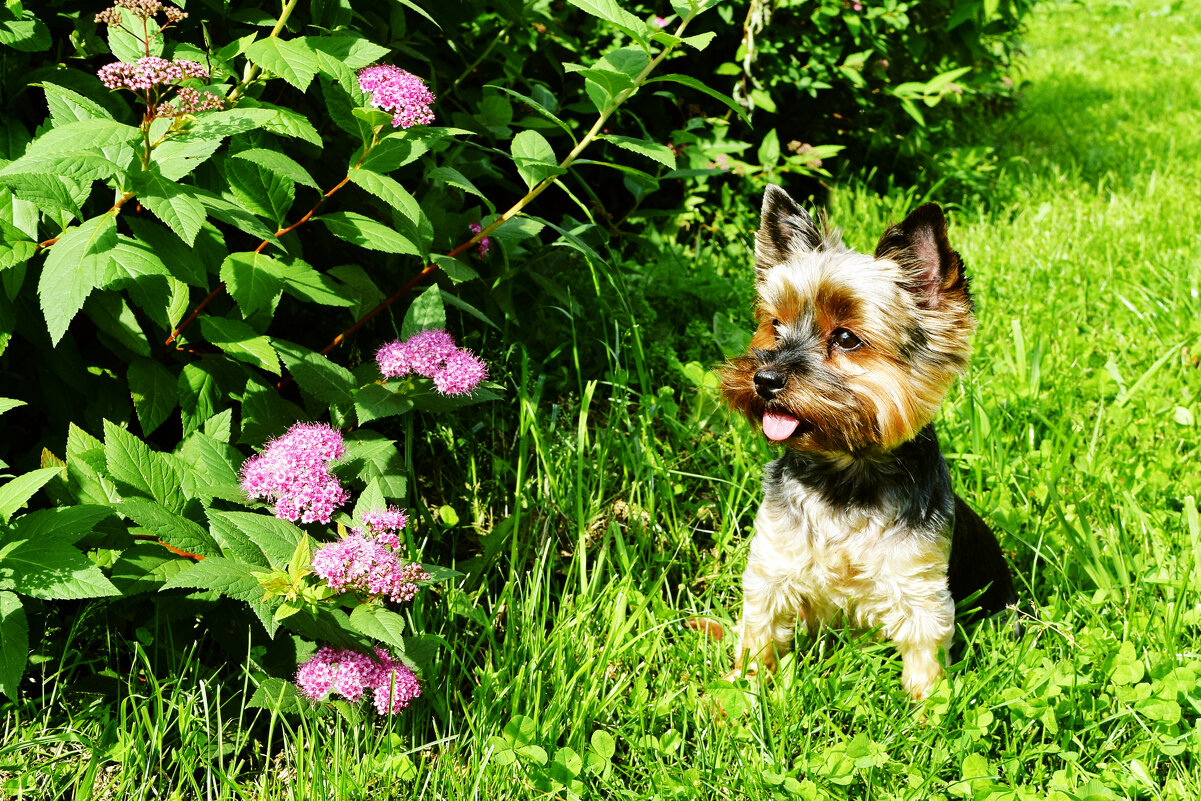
[876,203,968,309]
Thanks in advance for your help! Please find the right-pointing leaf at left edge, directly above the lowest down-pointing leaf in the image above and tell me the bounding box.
[0,533,120,600]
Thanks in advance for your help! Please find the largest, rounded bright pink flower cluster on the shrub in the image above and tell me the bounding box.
[241,423,347,522]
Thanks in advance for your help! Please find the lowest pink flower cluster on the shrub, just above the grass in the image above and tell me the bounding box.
[297,646,422,715]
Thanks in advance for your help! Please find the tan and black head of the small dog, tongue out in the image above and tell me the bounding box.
[722,186,975,454]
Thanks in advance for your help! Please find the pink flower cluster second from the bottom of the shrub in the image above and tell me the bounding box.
[311,528,430,603]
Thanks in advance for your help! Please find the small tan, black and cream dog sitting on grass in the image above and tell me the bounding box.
[722,186,1015,699]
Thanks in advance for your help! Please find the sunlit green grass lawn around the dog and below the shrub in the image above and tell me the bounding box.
[0,2,1201,801]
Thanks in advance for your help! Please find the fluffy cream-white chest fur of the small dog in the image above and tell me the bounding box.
[748,482,950,627]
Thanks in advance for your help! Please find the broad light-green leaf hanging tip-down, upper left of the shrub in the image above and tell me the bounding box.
[37,211,116,345]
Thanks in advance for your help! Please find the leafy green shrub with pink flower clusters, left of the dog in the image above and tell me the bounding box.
[0,0,734,715]
